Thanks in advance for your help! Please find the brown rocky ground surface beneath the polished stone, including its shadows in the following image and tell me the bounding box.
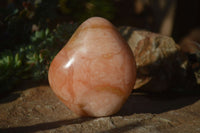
[0,86,200,133]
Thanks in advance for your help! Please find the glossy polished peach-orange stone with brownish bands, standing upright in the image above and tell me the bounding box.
[48,17,136,117]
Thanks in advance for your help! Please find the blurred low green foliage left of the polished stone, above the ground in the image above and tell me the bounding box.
[0,24,77,91]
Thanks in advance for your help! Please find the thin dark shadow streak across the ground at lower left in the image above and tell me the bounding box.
[0,118,92,133]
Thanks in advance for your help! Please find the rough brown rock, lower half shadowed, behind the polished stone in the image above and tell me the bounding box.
[119,27,192,91]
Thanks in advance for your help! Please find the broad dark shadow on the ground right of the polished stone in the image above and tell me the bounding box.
[116,93,200,116]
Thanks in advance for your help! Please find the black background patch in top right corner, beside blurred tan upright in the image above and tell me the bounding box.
[172,0,200,41]
